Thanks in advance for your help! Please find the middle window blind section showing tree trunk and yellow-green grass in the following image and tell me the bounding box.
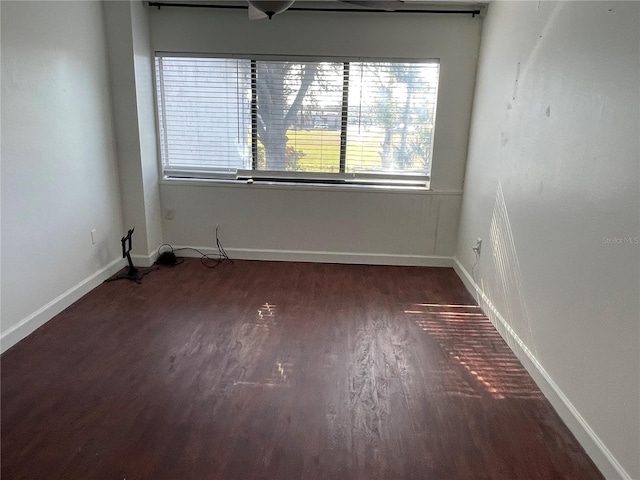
[255,61,344,173]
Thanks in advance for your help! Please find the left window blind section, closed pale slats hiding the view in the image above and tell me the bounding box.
[156,57,251,170]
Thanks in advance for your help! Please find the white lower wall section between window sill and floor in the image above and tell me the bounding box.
[162,185,460,266]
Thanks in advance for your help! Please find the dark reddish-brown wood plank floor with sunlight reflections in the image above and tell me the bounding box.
[1,259,602,480]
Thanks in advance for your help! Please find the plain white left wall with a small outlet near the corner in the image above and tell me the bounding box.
[0,1,122,350]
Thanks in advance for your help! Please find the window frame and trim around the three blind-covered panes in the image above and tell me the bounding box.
[152,51,441,191]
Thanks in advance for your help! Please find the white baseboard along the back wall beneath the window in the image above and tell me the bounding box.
[173,246,453,267]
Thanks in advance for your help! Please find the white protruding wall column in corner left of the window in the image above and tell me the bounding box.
[103,1,162,266]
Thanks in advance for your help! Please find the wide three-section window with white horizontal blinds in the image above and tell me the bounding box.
[156,54,439,186]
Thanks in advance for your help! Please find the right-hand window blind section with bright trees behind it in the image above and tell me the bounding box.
[346,62,439,175]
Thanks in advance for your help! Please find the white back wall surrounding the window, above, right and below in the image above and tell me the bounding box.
[150,8,481,264]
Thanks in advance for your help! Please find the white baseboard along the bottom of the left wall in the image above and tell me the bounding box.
[0,258,124,352]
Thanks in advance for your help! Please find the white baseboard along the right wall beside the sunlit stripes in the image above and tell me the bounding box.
[453,257,633,480]
